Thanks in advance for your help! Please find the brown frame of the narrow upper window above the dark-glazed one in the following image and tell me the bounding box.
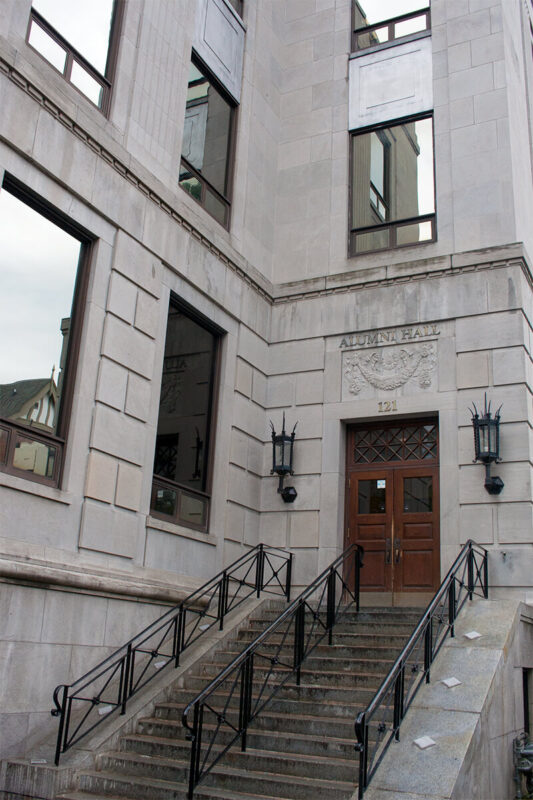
[178,50,239,230]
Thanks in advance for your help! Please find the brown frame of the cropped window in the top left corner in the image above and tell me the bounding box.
[26,0,124,117]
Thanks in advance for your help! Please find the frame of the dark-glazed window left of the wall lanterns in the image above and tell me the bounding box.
[150,292,225,533]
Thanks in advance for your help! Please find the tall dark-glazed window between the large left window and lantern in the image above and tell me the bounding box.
[151,299,219,530]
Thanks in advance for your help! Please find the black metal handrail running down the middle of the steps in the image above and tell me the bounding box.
[182,544,364,799]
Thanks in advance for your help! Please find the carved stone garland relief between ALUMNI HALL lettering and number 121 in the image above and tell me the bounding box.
[342,342,437,395]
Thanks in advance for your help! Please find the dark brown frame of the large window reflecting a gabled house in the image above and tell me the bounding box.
[0,173,95,489]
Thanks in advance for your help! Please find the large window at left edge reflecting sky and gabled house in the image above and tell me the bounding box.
[0,178,89,486]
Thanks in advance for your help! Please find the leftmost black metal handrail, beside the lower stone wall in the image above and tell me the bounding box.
[51,544,292,766]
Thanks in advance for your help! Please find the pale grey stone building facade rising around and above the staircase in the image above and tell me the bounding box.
[0,0,533,756]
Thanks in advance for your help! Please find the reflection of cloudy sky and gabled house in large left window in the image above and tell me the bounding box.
[0,189,80,438]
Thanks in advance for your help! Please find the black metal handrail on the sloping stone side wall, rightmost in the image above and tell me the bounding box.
[355,539,488,800]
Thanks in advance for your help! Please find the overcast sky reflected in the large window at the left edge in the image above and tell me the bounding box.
[0,189,80,384]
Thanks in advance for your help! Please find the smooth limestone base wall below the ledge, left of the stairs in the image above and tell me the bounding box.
[0,583,168,757]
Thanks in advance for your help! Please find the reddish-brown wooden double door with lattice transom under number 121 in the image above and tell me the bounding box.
[346,420,440,600]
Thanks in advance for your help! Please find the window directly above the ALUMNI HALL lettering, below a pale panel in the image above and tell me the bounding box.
[350,117,435,255]
